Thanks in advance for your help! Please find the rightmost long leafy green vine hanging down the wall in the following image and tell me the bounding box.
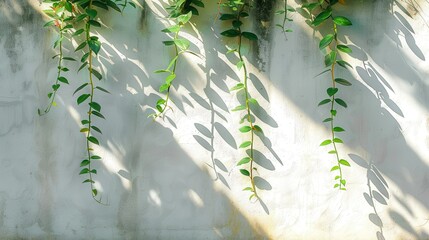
[303,0,352,190]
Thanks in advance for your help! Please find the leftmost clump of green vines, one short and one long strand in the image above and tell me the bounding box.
[39,0,130,204]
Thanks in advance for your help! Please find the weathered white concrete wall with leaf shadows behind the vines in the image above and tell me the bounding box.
[0,0,429,239]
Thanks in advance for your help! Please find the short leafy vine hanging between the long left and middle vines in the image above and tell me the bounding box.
[149,0,204,119]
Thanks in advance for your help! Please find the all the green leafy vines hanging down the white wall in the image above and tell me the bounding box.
[38,0,352,204]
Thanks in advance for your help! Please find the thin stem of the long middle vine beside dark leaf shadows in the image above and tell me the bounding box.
[237,5,259,199]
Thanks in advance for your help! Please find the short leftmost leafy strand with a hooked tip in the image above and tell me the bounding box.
[37,0,76,116]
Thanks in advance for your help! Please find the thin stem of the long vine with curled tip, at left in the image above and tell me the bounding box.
[86,0,106,205]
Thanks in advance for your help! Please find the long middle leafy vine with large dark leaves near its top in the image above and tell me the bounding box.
[219,0,262,200]
